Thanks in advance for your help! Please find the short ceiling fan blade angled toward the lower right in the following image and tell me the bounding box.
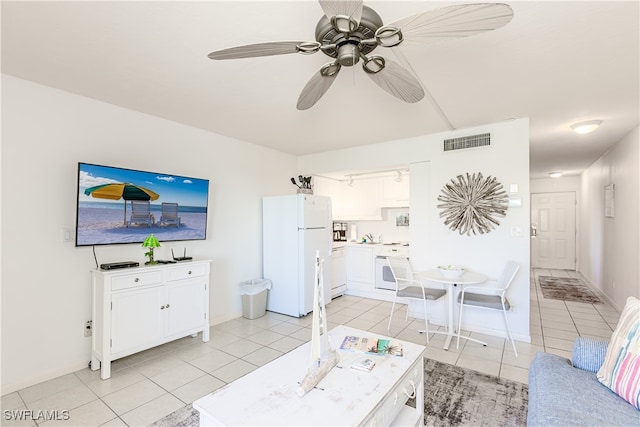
[363,57,424,103]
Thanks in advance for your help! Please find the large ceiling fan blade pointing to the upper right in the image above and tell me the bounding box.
[389,3,513,43]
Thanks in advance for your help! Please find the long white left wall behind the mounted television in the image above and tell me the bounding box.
[2,75,297,394]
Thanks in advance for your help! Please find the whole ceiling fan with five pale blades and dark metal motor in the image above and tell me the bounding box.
[209,0,513,110]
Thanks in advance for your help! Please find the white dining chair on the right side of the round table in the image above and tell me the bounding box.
[456,261,520,357]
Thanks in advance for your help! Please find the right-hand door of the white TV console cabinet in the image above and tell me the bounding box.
[164,281,208,338]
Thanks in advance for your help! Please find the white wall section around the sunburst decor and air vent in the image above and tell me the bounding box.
[299,119,530,341]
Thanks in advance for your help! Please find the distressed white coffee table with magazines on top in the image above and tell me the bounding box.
[193,326,425,426]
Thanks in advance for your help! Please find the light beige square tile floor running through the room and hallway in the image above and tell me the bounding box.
[2,269,619,426]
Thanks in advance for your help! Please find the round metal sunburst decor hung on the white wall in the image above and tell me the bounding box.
[438,172,509,236]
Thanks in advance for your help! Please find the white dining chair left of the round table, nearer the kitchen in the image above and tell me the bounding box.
[387,256,447,344]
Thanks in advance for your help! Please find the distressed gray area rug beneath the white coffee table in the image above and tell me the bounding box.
[151,358,529,427]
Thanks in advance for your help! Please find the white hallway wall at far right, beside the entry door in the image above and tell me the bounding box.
[578,128,640,309]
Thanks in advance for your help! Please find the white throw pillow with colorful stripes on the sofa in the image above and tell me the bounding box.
[597,297,640,409]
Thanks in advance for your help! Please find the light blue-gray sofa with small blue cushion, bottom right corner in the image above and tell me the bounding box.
[527,338,640,427]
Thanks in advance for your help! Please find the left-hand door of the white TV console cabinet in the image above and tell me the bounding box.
[111,286,165,356]
